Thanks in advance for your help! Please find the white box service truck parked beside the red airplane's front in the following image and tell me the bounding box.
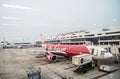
[72,54,95,73]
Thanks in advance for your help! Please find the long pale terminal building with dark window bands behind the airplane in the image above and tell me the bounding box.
[46,27,120,45]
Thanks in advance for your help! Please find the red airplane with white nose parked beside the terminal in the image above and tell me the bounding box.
[43,43,113,61]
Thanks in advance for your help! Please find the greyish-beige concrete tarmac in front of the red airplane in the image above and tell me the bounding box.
[0,48,119,79]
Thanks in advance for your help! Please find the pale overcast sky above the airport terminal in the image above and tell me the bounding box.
[0,0,120,42]
